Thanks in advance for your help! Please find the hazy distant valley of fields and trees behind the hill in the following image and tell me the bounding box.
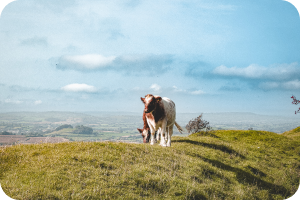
[0,112,300,146]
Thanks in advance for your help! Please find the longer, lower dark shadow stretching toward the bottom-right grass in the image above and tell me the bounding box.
[191,154,289,196]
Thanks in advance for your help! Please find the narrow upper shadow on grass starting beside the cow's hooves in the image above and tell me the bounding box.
[172,139,245,158]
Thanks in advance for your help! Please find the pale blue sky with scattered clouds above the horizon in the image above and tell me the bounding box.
[0,0,300,117]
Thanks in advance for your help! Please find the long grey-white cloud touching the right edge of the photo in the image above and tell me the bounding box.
[212,63,300,81]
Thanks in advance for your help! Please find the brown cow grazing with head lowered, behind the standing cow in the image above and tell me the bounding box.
[137,112,182,143]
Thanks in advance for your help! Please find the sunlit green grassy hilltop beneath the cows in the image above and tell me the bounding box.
[0,129,300,199]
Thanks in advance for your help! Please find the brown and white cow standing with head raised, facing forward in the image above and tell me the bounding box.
[141,94,182,147]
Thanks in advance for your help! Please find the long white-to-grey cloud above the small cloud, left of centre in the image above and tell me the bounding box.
[56,54,173,75]
